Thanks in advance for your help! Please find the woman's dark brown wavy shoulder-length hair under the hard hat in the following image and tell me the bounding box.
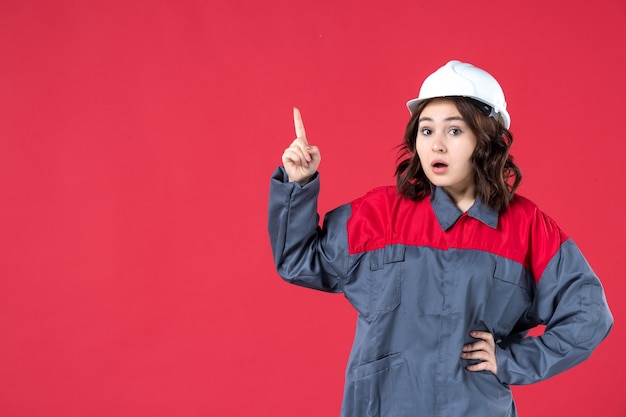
[396,97,522,213]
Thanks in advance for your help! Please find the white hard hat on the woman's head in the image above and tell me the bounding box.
[406,61,511,129]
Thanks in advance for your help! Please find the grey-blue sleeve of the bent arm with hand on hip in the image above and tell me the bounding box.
[497,239,613,384]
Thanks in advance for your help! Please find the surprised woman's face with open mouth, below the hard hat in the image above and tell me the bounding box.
[415,99,477,195]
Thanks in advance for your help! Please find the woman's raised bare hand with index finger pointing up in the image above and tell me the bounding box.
[282,107,322,185]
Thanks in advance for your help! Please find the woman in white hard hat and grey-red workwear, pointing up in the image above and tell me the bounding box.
[269,61,613,417]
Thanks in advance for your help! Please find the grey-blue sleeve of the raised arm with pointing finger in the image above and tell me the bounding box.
[268,167,350,292]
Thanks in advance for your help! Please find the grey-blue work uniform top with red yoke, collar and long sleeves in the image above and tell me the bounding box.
[269,167,613,417]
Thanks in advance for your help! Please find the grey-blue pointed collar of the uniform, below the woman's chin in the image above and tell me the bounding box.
[430,187,498,230]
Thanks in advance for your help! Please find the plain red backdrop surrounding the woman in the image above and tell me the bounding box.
[0,0,626,417]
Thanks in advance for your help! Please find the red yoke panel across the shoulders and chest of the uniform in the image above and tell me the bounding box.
[347,186,568,281]
